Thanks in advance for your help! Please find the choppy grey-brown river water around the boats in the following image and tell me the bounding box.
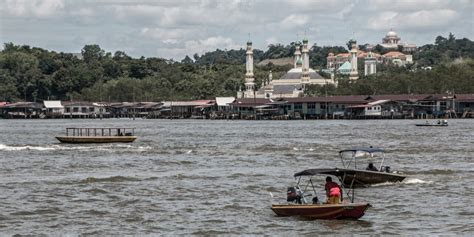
[0,119,474,236]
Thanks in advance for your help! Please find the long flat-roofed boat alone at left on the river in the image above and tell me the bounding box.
[56,128,137,143]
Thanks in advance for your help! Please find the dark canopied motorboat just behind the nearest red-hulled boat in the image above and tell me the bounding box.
[336,147,406,188]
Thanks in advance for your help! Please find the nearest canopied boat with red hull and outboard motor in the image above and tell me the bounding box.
[271,169,371,219]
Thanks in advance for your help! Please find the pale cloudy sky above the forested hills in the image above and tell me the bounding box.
[0,0,474,61]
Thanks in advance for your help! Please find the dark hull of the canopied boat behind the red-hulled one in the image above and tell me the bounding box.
[338,170,406,187]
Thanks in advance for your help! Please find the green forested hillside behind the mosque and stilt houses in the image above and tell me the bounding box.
[0,34,474,101]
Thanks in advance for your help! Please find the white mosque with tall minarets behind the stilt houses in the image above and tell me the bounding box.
[237,39,336,99]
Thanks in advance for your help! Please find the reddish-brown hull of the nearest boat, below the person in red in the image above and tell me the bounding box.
[272,203,371,219]
